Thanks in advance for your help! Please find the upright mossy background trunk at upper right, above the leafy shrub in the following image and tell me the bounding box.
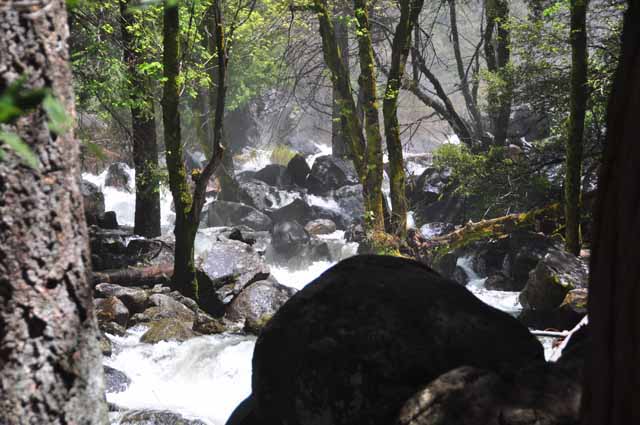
[484,0,513,148]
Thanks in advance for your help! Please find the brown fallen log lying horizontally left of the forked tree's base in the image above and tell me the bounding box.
[91,264,173,286]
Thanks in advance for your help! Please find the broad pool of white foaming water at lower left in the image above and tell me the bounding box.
[104,326,255,425]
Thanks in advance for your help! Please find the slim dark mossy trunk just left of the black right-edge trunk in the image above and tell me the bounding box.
[564,0,589,255]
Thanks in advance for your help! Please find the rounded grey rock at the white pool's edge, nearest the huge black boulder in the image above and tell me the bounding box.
[225,280,296,334]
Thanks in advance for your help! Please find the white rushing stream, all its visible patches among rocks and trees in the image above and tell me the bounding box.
[83,148,553,425]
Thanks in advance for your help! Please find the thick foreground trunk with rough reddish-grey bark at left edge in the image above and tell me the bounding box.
[0,0,107,425]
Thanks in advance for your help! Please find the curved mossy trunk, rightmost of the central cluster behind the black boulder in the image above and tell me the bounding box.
[383,0,424,238]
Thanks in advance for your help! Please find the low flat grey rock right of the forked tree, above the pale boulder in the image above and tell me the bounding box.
[207,201,272,230]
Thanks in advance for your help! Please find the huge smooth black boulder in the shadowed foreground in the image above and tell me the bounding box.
[246,256,543,425]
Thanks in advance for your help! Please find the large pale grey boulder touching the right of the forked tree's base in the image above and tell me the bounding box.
[198,240,269,317]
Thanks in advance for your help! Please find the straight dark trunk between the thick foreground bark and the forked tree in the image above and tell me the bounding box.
[120,0,160,238]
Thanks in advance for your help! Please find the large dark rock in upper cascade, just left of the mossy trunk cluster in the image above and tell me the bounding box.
[306,155,358,195]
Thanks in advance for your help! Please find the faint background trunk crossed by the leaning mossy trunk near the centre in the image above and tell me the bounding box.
[331,17,349,158]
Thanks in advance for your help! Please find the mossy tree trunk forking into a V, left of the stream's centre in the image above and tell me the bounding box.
[162,1,226,300]
